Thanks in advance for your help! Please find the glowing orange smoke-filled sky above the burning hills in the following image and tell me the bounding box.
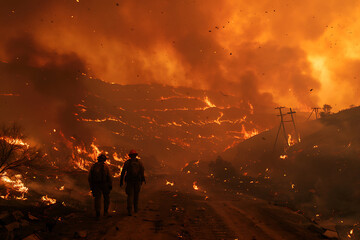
[0,0,360,109]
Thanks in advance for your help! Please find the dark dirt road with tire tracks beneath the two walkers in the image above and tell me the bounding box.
[50,173,322,240]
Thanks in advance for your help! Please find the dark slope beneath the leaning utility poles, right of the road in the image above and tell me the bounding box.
[219,107,360,229]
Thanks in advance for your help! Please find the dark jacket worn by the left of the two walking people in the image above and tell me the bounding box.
[88,162,112,190]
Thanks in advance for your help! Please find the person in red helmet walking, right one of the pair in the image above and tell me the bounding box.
[120,150,146,216]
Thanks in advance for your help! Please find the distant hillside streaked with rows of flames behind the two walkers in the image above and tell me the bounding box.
[1,55,274,169]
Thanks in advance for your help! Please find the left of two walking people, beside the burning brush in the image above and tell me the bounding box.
[88,154,112,219]
